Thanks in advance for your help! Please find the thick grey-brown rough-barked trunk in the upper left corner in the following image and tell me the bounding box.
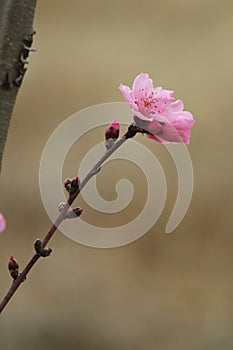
[0,0,36,171]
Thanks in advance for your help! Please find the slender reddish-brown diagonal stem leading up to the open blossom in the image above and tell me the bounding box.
[0,135,129,313]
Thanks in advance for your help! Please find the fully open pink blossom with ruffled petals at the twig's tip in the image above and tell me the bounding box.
[119,73,194,143]
